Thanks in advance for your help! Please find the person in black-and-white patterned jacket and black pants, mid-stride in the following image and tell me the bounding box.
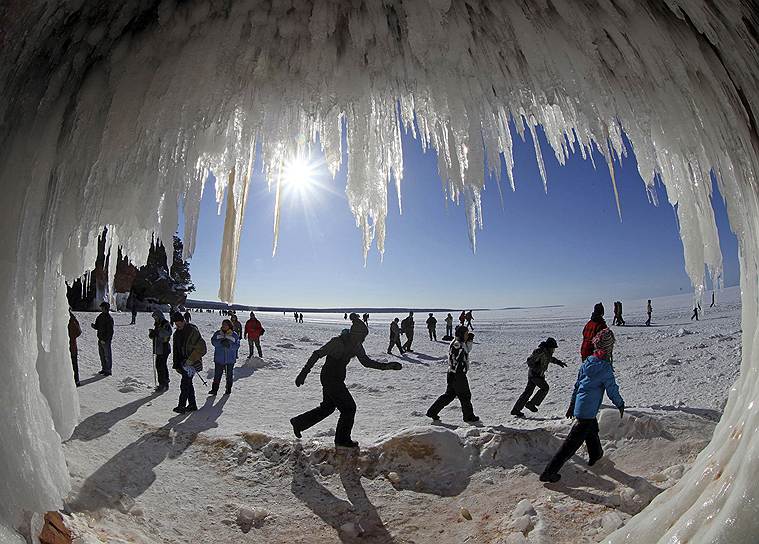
[427,325,480,423]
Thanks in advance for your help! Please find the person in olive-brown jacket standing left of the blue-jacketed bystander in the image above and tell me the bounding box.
[171,312,206,414]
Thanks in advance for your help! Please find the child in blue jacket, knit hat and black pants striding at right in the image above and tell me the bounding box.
[540,329,625,482]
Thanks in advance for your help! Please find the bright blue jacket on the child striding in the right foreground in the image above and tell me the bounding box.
[569,355,625,419]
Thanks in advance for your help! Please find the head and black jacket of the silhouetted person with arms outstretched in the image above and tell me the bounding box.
[301,319,391,383]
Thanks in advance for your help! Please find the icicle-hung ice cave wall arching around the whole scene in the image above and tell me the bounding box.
[0,0,759,542]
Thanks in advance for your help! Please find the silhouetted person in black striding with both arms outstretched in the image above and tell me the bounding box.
[290,314,403,448]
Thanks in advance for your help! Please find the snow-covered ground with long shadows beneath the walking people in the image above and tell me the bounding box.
[60,288,741,543]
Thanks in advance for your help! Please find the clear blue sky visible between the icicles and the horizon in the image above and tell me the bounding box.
[183,124,738,308]
